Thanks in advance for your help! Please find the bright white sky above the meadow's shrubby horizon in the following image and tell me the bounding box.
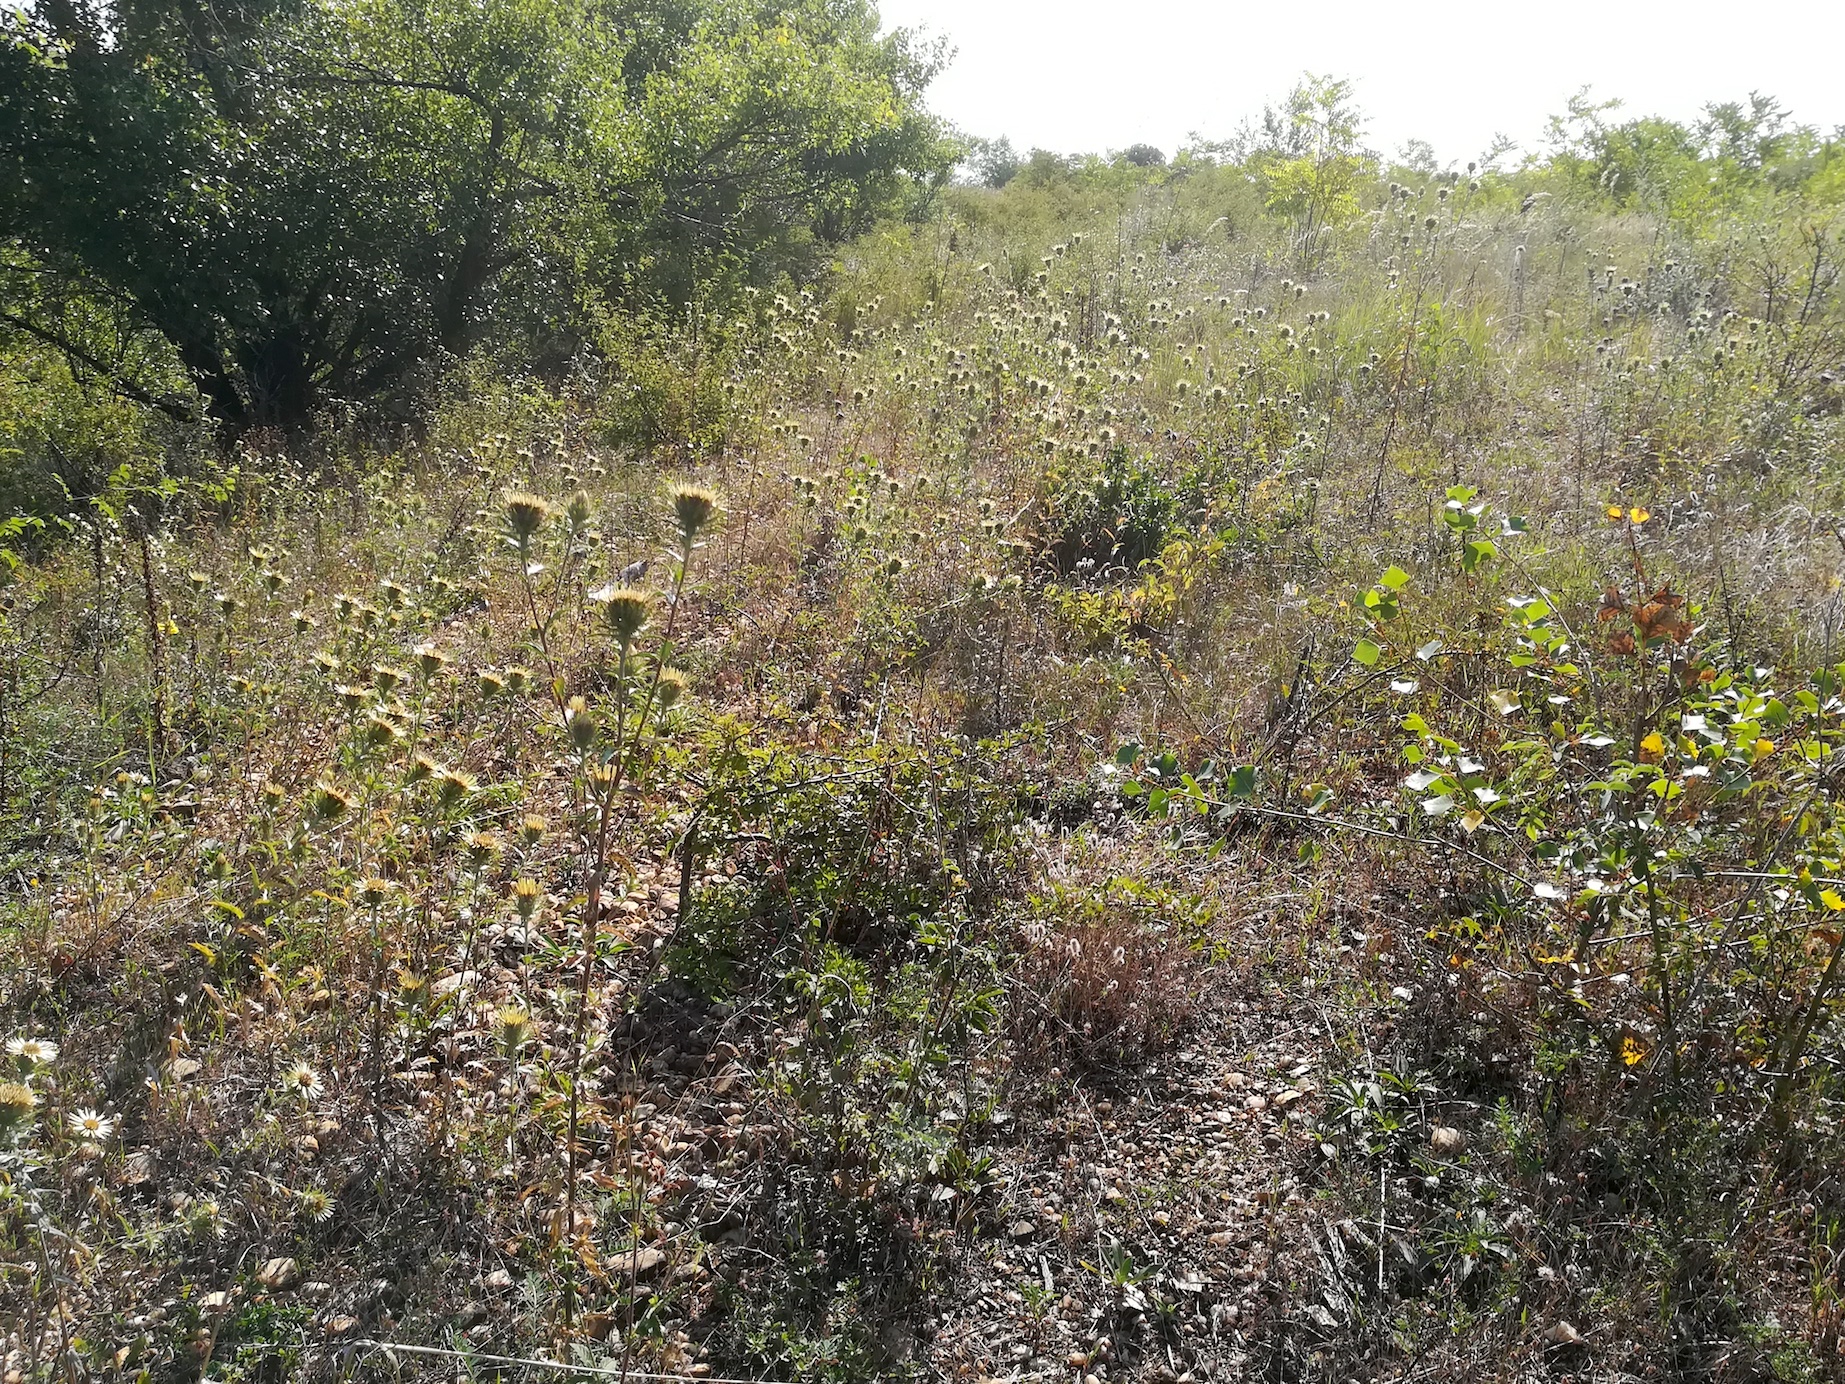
[878,0,1845,162]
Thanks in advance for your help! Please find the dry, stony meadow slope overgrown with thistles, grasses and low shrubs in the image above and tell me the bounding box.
[0,73,1845,1384]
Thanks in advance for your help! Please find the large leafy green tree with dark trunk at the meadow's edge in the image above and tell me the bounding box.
[0,0,954,428]
